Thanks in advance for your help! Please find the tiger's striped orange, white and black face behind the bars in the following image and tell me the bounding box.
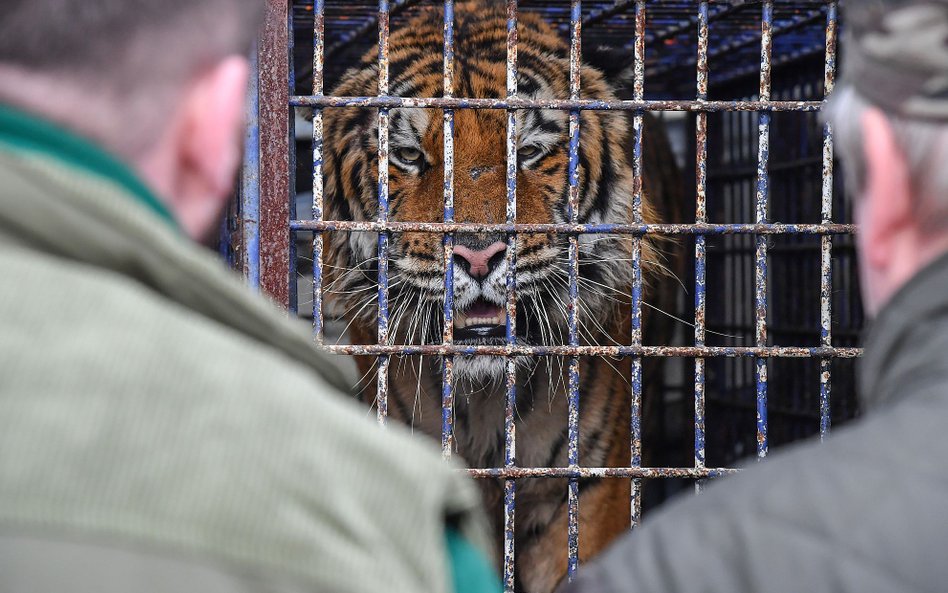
[324,3,654,383]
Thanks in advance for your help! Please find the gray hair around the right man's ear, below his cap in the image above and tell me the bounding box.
[824,85,948,231]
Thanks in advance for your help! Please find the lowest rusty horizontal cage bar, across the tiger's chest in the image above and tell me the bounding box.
[461,467,740,479]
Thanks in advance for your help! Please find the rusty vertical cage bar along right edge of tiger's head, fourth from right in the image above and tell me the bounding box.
[629,0,645,528]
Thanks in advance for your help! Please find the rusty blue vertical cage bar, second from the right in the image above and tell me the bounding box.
[754,0,774,459]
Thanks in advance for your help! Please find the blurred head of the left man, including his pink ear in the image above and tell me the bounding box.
[0,0,263,237]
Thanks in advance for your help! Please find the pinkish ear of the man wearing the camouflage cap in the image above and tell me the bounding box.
[859,107,912,269]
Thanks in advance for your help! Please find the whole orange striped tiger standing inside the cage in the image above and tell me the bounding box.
[323,0,679,593]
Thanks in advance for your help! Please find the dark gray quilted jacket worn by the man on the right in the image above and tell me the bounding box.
[566,256,948,593]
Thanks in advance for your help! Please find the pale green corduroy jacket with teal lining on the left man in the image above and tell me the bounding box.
[0,106,496,593]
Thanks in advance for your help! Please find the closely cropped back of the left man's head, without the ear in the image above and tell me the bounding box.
[0,0,263,159]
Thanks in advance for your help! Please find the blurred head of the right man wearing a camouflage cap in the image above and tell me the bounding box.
[828,0,948,314]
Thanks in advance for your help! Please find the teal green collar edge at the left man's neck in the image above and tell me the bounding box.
[0,104,178,227]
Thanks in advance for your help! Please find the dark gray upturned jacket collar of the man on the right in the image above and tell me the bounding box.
[858,253,948,408]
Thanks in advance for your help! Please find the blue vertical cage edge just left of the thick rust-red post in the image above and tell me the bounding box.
[240,40,260,292]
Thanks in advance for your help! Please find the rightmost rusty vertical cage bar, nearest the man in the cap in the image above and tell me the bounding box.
[820,1,837,440]
